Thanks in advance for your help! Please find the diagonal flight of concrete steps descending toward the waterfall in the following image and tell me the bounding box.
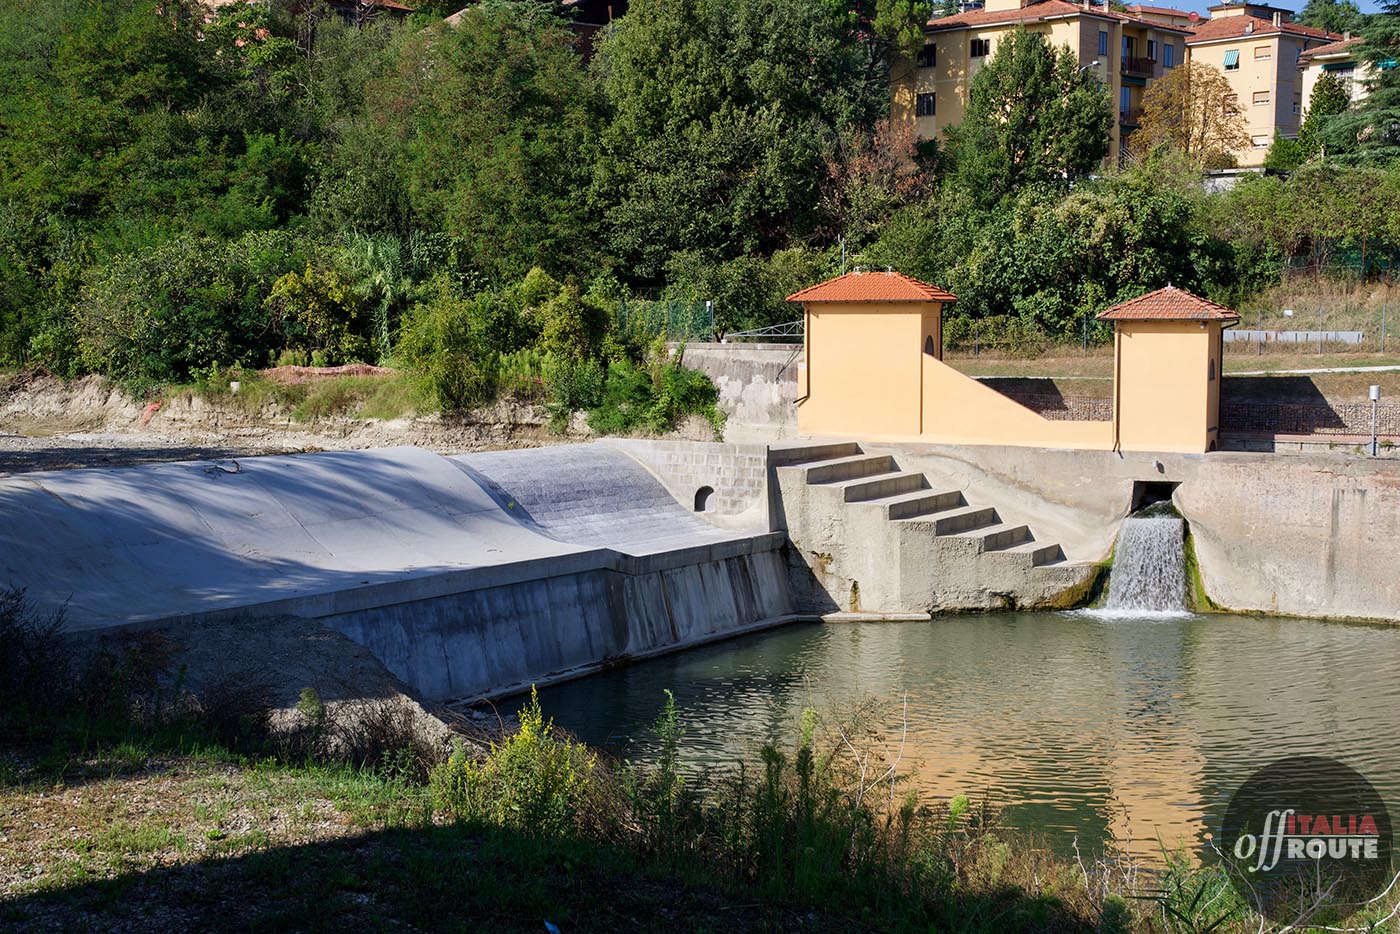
[776,442,1064,567]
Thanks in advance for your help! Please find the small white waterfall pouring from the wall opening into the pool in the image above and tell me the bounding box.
[1107,518,1186,613]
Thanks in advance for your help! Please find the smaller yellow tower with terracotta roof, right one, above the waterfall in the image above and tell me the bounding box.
[1099,286,1239,454]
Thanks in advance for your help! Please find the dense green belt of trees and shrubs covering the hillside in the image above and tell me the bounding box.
[0,0,1400,386]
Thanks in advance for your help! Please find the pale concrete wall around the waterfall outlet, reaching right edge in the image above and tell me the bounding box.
[869,445,1400,622]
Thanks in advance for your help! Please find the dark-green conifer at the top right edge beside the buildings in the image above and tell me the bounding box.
[1322,0,1400,164]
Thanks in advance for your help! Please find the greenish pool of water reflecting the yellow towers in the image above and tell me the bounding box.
[526,613,1400,856]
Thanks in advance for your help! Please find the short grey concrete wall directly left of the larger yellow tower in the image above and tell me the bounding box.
[685,343,802,438]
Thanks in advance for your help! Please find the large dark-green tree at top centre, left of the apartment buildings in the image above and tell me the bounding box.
[592,0,889,283]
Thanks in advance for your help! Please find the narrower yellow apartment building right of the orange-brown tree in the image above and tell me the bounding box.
[1187,3,1341,167]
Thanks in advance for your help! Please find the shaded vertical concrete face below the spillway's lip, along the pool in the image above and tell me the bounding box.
[321,535,794,700]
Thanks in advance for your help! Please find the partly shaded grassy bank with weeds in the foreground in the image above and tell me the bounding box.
[0,595,1394,931]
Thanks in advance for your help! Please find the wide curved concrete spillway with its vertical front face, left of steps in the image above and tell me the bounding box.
[0,445,791,699]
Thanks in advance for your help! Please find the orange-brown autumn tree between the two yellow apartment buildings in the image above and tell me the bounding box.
[1134,62,1249,168]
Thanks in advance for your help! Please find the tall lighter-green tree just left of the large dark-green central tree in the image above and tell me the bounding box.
[368,1,602,280]
